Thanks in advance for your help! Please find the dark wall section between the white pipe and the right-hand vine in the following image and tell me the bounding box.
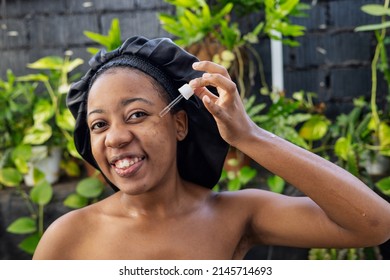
[284,0,387,115]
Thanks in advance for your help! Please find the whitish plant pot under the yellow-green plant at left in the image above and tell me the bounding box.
[24,146,62,187]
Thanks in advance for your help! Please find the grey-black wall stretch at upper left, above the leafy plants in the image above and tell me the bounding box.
[0,0,172,77]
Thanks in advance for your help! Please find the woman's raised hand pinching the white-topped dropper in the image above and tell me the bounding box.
[190,61,254,146]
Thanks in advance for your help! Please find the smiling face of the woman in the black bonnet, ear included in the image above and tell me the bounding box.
[87,68,187,194]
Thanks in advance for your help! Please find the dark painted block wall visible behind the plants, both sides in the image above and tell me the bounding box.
[0,0,383,114]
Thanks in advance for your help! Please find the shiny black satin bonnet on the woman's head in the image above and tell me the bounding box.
[67,36,228,190]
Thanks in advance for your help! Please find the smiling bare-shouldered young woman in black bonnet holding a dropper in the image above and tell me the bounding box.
[34,37,390,259]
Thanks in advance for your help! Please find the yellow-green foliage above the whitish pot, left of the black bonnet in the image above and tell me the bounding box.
[17,56,83,180]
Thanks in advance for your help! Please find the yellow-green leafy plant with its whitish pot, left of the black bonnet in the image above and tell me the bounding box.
[17,56,83,185]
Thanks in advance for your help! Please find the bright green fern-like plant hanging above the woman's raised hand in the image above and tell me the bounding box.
[159,0,304,98]
